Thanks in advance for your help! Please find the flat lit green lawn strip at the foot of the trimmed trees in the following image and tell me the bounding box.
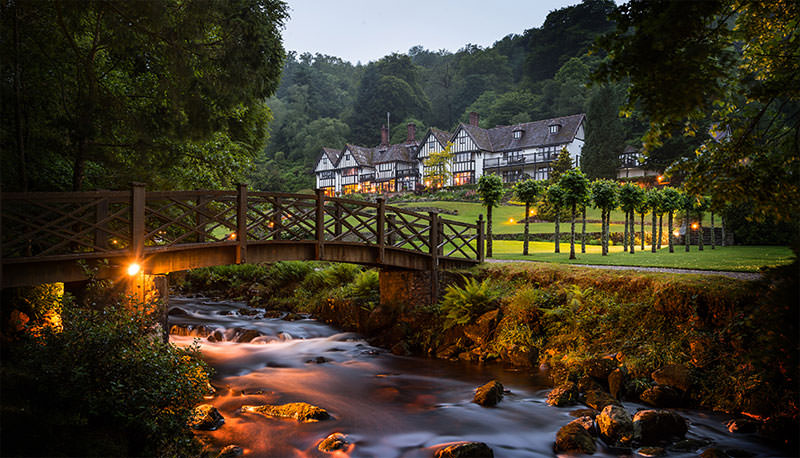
[492,240,794,272]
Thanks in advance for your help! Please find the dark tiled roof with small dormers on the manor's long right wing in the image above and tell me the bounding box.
[460,113,586,152]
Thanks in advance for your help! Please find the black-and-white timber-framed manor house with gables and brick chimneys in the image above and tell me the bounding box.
[315,112,586,194]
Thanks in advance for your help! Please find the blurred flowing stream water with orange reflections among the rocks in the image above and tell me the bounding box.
[169,297,779,458]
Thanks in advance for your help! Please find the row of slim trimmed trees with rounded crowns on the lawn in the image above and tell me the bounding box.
[477,169,725,259]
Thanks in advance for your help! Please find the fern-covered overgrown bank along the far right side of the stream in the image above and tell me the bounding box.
[177,262,800,451]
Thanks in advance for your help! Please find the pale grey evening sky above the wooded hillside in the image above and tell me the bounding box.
[283,0,580,64]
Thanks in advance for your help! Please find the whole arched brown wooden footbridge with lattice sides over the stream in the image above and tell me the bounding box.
[0,184,484,287]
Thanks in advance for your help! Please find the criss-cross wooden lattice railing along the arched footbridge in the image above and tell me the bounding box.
[0,184,483,264]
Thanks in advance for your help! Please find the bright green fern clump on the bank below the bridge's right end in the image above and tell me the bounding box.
[440,277,501,329]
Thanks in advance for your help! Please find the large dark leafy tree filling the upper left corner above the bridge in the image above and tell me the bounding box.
[0,0,288,190]
